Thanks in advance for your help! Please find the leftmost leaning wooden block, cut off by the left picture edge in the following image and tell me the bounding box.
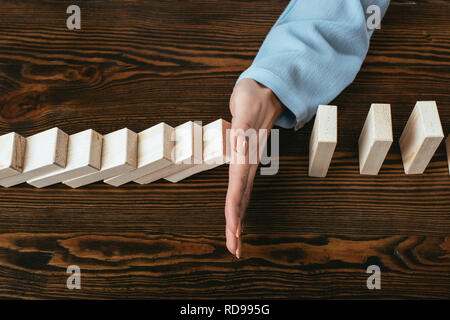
[0,132,26,179]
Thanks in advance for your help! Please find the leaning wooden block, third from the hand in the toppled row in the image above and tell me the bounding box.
[104,122,175,187]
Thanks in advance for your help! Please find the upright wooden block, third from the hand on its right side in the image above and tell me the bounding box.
[400,101,444,174]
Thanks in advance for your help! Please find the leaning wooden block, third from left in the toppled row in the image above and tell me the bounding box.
[27,129,103,188]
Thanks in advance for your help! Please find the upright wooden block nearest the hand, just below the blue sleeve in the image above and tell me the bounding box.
[309,105,337,177]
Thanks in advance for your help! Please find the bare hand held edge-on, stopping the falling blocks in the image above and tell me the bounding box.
[225,79,283,258]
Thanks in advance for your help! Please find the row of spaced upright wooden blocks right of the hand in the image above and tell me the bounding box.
[309,101,450,177]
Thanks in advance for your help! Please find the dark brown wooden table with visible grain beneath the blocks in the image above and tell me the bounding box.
[0,0,450,298]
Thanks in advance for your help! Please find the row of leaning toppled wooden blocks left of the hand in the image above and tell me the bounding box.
[0,119,231,188]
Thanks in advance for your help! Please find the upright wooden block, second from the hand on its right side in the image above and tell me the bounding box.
[358,103,393,175]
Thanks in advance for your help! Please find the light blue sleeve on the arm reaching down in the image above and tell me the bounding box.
[237,0,389,129]
